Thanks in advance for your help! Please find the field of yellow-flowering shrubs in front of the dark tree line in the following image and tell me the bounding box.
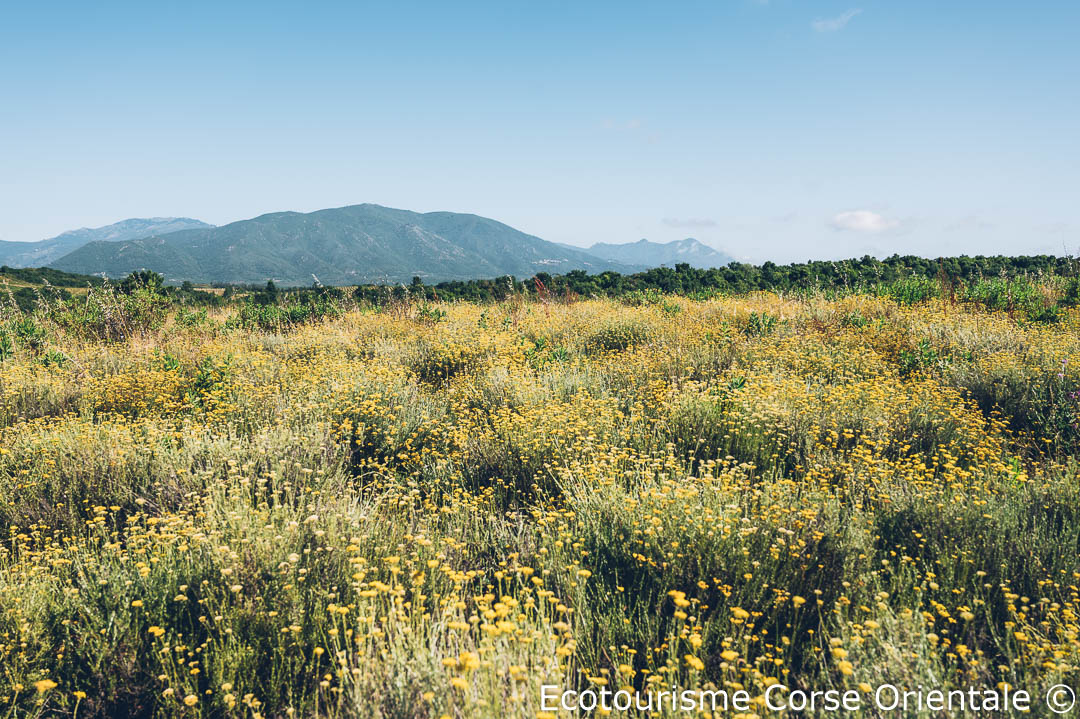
[0,294,1080,719]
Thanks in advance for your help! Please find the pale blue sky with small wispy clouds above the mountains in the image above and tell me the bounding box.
[0,0,1080,262]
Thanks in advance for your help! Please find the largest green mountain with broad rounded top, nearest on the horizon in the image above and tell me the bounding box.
[51,204,642,285]
